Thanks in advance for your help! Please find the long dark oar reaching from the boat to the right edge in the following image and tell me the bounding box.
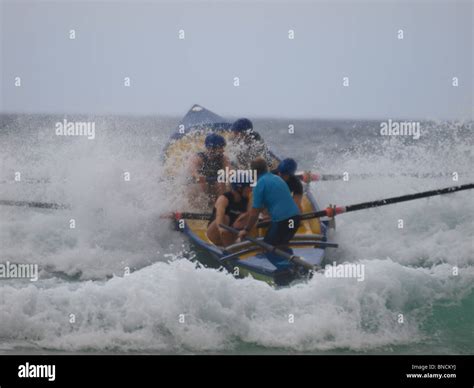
[257,183,474,227]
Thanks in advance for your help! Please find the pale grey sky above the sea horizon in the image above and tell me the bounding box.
[1,0,474,119]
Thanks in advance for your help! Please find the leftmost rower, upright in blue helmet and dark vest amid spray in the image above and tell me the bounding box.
[191,133,230,203]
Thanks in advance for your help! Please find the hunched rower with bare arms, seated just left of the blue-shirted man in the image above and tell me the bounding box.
[207,183,252,246]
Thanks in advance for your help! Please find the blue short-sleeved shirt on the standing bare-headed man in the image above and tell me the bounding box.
[252,172,300,222]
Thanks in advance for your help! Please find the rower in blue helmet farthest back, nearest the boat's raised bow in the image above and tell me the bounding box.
[230,118,271,169]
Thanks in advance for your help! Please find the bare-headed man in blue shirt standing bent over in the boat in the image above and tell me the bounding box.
[239,158,300,245]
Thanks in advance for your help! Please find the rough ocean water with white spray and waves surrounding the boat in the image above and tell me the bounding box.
[0,115,474,354]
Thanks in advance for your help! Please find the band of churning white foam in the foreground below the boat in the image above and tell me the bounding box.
[0,260,474,352]
